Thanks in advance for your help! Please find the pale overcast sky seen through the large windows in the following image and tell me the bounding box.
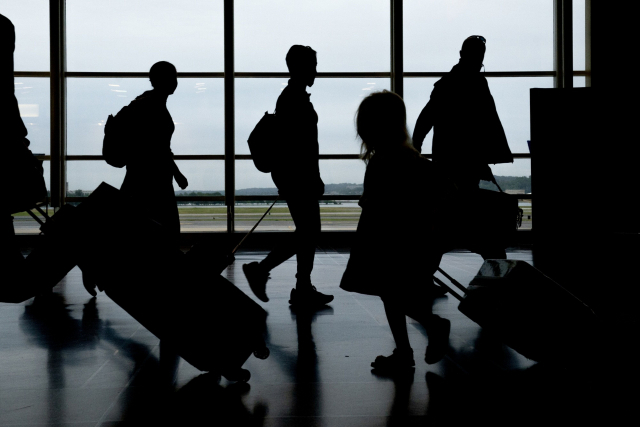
[0,0,584,190]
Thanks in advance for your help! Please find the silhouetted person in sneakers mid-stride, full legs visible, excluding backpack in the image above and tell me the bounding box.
[242,45,333,306]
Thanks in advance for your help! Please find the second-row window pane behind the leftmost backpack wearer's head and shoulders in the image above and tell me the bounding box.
[67,78,224,155]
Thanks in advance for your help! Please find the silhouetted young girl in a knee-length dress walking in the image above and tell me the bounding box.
[340,91,452,372]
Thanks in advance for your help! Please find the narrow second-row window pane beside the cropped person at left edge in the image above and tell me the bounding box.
[14,77,51,154]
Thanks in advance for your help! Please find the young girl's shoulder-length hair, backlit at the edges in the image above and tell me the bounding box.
[355,90,415,163]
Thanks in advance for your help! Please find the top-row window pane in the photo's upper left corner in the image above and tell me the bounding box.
[0,0,49,71]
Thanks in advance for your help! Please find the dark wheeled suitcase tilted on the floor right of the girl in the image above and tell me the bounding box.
[434,260,596,361]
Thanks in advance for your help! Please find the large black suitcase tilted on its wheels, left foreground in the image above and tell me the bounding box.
[78,183,268,380]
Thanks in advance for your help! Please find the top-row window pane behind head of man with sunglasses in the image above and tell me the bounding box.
[404,0,553,71]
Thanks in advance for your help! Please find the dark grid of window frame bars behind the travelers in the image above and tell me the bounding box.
[14,0,591,233]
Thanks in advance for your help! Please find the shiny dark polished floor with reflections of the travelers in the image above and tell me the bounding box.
[0,249,637,427]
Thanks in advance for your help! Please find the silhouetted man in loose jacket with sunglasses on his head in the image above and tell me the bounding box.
[413,36,513,259]
